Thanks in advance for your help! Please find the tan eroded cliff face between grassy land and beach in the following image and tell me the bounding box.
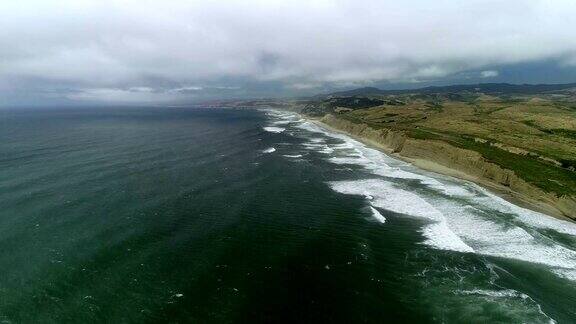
[320,115,576,220]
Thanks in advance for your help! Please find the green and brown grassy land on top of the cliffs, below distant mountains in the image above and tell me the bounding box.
[304,92,576,195]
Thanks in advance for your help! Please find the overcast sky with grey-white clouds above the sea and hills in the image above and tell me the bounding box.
[0,0,576,105]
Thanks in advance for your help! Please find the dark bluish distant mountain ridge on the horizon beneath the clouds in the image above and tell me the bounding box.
[316,83,576,98]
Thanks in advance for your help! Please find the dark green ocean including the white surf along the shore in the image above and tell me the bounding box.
[0,108,576,323]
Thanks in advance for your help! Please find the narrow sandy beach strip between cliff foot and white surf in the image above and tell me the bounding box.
[310,116,576,223]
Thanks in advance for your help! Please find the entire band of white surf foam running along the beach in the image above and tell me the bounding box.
[272,114,576,280]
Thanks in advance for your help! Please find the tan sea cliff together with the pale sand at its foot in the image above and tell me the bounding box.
[318,114,576,221]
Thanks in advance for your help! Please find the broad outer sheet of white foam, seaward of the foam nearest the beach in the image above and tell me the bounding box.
[330,179,576,280]
